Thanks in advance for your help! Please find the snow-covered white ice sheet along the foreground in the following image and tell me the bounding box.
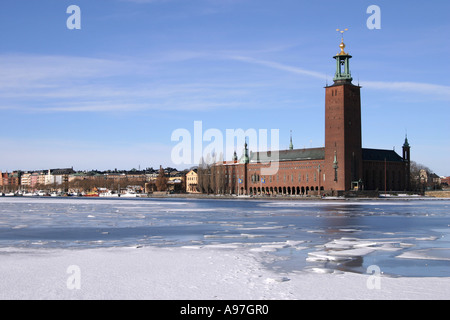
[0,247,450,300]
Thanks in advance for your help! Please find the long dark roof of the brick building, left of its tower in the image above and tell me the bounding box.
[250,148,325,163]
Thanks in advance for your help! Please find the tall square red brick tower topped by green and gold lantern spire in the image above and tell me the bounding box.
[324,32,363,193]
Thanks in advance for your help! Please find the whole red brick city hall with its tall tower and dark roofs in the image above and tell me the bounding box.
[213,40,410,195]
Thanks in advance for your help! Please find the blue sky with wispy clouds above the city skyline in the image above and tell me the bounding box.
[0,0,450,175]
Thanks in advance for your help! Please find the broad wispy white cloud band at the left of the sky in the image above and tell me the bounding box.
[0,53,251,112]
